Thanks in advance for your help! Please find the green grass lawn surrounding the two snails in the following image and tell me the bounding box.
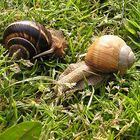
[0,0,140,140]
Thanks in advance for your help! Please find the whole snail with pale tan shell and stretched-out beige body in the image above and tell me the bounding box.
[55,35,135,92]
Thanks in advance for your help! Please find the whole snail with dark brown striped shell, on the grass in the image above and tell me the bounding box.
[3,20,66,59]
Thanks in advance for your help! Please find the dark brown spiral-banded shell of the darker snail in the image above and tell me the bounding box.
[3,21,52,59]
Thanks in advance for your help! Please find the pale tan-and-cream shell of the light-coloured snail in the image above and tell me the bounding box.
[85,35,135,74]
